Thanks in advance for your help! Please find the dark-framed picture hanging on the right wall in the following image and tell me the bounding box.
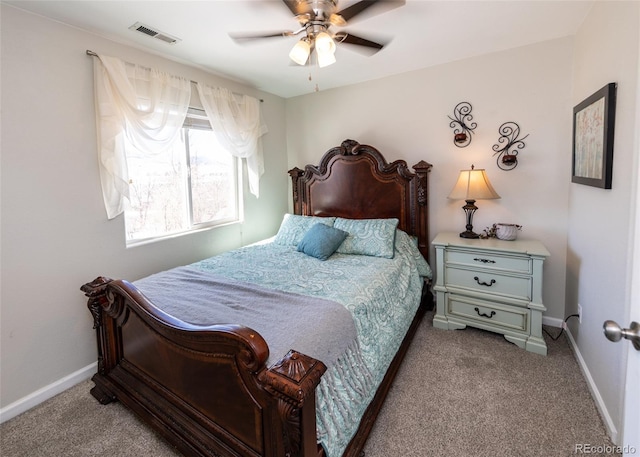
[571,83,617,189]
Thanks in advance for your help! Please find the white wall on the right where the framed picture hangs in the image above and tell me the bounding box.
[567,2,640,440]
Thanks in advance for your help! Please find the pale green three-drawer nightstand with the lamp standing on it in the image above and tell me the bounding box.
[432,232,550,355]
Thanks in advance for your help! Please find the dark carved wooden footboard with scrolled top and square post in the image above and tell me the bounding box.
[81,277,326,457]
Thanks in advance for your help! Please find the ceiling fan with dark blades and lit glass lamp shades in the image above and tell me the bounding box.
[230,0,405,67]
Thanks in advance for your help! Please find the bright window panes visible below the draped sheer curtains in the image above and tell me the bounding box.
[125,109,242,245]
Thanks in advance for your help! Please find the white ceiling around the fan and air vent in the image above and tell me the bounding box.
[3,0,593,98]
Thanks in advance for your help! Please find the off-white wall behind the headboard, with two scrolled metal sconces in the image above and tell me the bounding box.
[286,38,573,322]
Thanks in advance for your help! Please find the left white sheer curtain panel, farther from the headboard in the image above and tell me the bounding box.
[94,55,191,219]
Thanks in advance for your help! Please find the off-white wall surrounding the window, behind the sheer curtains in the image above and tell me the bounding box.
[0,4,289,407]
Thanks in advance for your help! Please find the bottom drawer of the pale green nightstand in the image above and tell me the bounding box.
[447,294,529,333]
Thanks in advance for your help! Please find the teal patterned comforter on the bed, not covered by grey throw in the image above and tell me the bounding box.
[192,230,431,457]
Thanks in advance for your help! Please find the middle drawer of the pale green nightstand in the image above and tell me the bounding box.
[445,267,531,301]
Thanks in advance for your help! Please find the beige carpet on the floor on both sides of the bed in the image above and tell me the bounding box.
[0,313,619,457]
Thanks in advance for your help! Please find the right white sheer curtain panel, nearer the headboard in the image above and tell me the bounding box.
[197,83,267,197]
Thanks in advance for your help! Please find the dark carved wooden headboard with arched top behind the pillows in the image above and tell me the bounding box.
[289,140,431,261]
